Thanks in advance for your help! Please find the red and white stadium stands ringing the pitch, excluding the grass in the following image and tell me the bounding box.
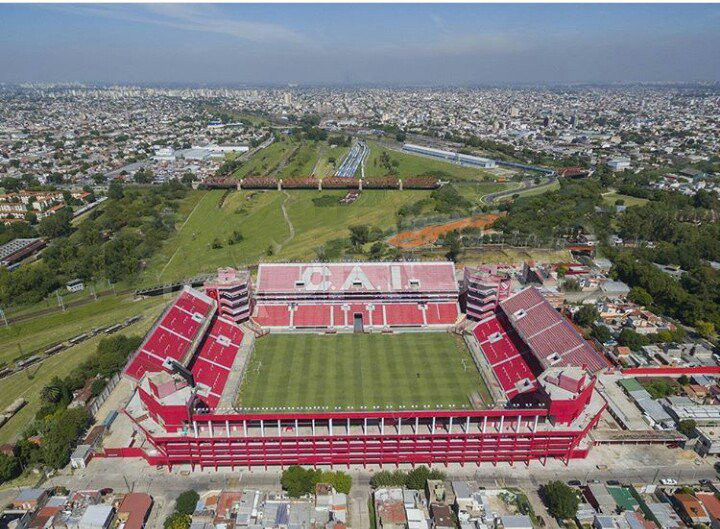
[115,263,607,468]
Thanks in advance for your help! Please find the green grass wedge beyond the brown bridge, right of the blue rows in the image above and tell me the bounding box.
[365,141,495,180]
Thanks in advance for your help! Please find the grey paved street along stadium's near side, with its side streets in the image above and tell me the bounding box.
[36,446,717,529]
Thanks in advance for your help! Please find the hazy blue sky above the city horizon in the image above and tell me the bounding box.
[0,4,720,85]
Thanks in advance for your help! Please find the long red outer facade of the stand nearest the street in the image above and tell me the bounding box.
[125,406,604,469]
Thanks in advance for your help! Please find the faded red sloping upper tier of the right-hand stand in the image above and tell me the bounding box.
[500,287,608,373]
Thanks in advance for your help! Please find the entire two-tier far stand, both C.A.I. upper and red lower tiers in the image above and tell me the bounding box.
[253,262,459,329]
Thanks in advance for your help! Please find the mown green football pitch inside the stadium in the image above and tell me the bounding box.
[238,333,487,411]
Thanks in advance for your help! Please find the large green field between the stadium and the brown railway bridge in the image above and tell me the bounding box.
[144,190,427,284]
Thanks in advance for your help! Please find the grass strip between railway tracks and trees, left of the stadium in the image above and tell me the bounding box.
[0,298,164,444]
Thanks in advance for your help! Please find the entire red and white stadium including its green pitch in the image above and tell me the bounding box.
[112,262,608,469]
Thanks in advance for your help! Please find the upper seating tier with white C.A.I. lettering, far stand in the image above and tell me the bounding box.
[256,262,458,294]
